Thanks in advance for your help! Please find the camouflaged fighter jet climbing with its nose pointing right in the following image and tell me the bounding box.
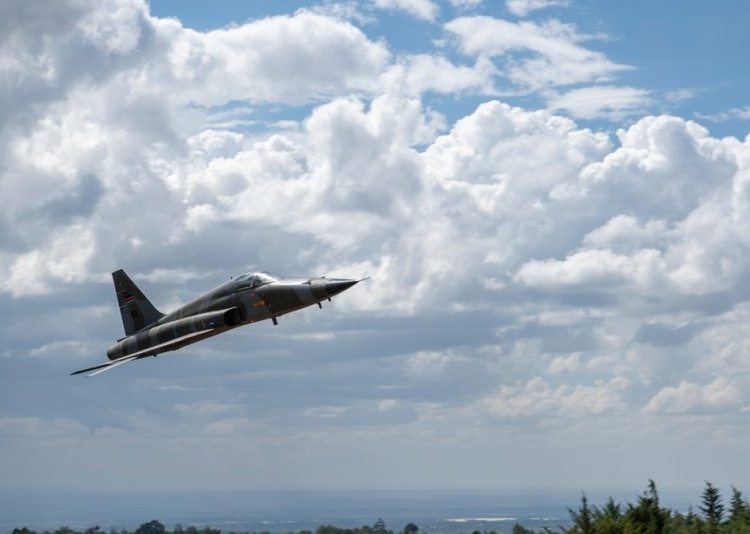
[70,269,362,376]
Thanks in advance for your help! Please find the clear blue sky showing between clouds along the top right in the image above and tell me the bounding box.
[150,0,750,137]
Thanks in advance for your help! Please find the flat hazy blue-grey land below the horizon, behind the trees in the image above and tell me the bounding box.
[0,489,700,534]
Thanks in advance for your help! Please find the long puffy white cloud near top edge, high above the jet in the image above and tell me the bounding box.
[161,11,389,106]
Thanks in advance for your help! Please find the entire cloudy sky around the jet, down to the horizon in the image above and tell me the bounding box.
[0,0,750,498]
